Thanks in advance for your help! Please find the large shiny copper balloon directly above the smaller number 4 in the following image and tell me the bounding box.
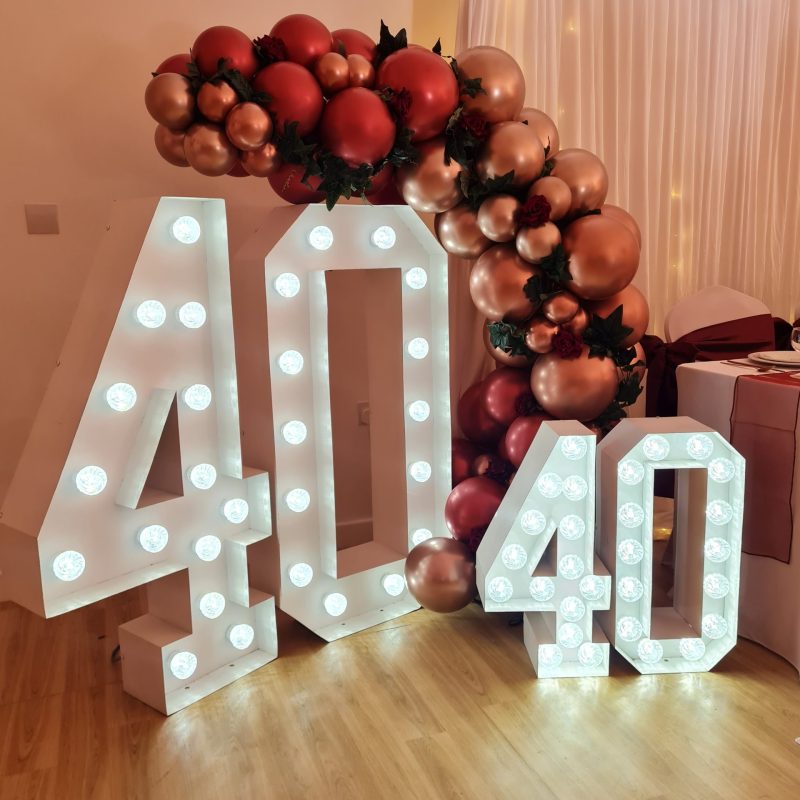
[531,346,619,422]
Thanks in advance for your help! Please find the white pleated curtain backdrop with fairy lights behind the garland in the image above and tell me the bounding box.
[453,0,800,356]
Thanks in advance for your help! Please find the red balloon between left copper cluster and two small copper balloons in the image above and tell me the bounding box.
[253,61,323,136]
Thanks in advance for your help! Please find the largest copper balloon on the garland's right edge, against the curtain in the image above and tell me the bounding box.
[563,214,639,300]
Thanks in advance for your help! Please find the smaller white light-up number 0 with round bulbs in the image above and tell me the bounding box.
[598,417,744,673]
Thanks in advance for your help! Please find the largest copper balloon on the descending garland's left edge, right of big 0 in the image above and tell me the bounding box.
[469,244,539,322]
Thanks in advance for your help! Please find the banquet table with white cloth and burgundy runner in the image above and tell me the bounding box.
[677,361,800,670]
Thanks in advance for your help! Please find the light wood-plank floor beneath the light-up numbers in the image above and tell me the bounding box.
[0,591,800,800]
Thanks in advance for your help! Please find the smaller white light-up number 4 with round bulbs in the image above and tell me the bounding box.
[477,421,611,678]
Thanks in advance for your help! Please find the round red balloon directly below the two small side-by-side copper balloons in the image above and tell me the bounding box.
[320,87,396,167]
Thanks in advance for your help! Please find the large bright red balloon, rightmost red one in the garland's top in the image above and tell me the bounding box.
[376,47,459,142]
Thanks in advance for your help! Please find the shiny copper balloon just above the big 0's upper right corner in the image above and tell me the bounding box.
[397,136,464,214]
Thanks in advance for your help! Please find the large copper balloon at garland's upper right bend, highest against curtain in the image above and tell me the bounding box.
[456,46,525,122]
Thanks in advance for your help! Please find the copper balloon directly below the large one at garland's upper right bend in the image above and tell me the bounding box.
[475,122,544,186]
